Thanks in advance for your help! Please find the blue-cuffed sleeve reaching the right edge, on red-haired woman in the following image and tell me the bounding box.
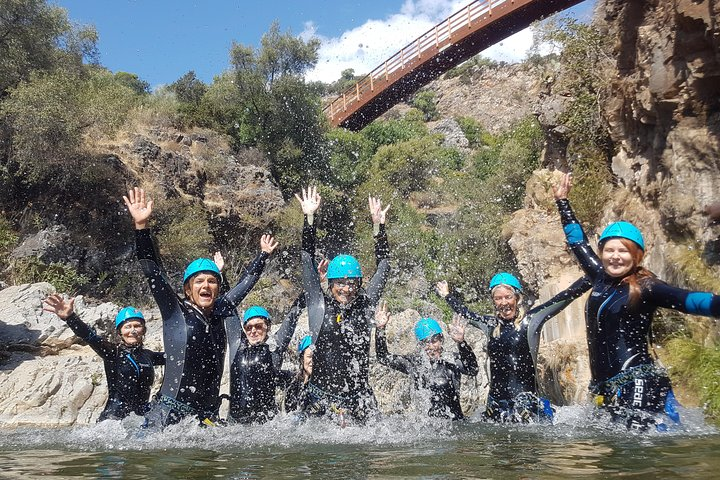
[641,279,720,318]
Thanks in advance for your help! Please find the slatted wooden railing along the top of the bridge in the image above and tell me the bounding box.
[324,0,515,124]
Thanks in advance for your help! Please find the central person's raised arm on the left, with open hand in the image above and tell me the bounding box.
[295,187,325,343]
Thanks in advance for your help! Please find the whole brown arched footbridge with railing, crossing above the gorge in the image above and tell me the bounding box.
[325,0,582,130]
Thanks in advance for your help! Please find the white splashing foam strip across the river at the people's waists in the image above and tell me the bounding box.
[0,406,718,452]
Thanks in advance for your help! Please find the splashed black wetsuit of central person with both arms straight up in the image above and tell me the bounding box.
[301,218,390,421]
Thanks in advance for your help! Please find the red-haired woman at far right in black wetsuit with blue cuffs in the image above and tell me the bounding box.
[553,174,720,430]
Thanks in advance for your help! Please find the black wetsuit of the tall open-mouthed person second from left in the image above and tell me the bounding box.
[135,229,268,427]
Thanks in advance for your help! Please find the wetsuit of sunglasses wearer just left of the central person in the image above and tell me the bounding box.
[228,294,305,423]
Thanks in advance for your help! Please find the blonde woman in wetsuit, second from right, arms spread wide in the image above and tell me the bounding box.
[436,272,590,422]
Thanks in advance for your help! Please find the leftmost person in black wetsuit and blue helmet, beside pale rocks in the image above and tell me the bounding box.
[43,294,165,422]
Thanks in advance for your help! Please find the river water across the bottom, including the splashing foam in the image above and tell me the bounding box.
[0,407,720,479]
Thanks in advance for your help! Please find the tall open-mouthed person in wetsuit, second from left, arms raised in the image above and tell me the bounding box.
[123,187,277,428]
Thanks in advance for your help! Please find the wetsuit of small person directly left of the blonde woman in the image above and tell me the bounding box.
[375,328,478,420]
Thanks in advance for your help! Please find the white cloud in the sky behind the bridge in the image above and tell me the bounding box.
[301,0,532,83]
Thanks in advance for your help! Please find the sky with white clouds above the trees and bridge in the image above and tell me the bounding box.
[49,0,595,87]
